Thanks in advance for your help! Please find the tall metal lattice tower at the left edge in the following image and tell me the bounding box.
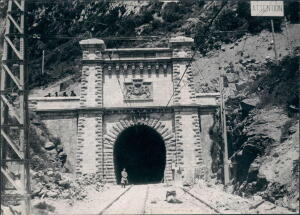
[0,0,30,215]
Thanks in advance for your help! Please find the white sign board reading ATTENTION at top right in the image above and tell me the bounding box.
[250,1,284,16]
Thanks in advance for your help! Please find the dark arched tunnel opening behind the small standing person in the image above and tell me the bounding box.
[114,125,166,184]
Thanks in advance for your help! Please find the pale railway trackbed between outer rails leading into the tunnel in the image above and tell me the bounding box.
[99,184,220,215]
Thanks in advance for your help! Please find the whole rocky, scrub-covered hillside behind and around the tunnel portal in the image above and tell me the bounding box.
[0,0,300,211]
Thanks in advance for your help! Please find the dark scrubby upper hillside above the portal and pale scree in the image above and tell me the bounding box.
[0,0,298,87]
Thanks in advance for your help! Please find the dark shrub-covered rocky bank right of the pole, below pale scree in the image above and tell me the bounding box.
[220,56,300,210]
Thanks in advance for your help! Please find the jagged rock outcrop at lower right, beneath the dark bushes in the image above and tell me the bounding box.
[226,100,299,210]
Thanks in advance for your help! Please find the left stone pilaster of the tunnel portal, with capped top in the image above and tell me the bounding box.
[76,39,105,175]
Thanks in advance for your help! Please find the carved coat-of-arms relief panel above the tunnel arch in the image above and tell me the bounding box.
[124,79,153,101]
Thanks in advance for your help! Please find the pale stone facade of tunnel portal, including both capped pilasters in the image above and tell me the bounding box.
[76,37,218,183]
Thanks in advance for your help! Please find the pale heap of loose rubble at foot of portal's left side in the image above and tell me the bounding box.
[32,168,104,200]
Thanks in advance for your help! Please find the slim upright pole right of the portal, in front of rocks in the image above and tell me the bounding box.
[219,68,230,185]
